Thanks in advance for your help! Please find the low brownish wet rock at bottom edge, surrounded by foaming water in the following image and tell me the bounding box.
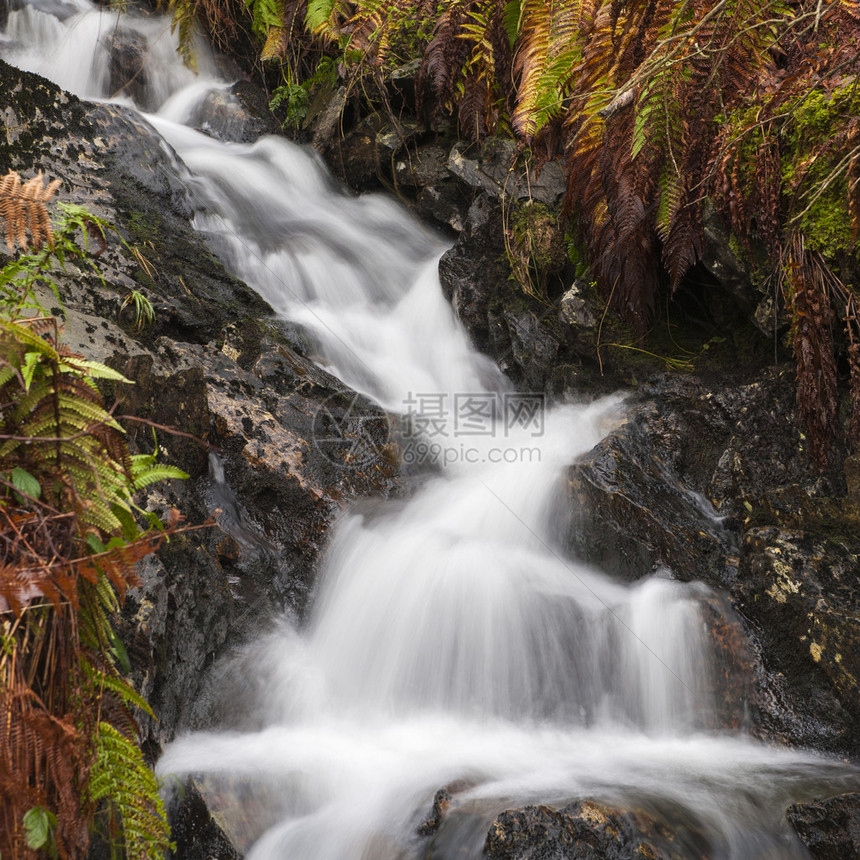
[485,800,713,860]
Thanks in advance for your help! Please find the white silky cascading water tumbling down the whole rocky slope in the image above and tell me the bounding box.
[0,5,856,860]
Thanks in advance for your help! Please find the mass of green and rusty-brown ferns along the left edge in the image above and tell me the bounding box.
[0,171,184,860]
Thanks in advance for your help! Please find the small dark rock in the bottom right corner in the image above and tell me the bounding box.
[786,793,860,860]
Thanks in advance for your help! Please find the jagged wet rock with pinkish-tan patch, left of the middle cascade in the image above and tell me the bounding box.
[116,330,400,741]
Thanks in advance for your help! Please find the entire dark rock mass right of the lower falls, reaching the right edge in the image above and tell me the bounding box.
[556,370,860,754]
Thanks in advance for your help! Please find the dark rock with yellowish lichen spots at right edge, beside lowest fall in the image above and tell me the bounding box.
[733,526,860,754]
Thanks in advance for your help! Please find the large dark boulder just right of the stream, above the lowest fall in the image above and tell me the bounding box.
[570,370,817,585]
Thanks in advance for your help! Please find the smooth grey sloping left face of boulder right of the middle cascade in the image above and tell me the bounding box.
[568,386,737,585]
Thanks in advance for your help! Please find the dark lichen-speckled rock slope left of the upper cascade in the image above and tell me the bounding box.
[0,61,270,345]
